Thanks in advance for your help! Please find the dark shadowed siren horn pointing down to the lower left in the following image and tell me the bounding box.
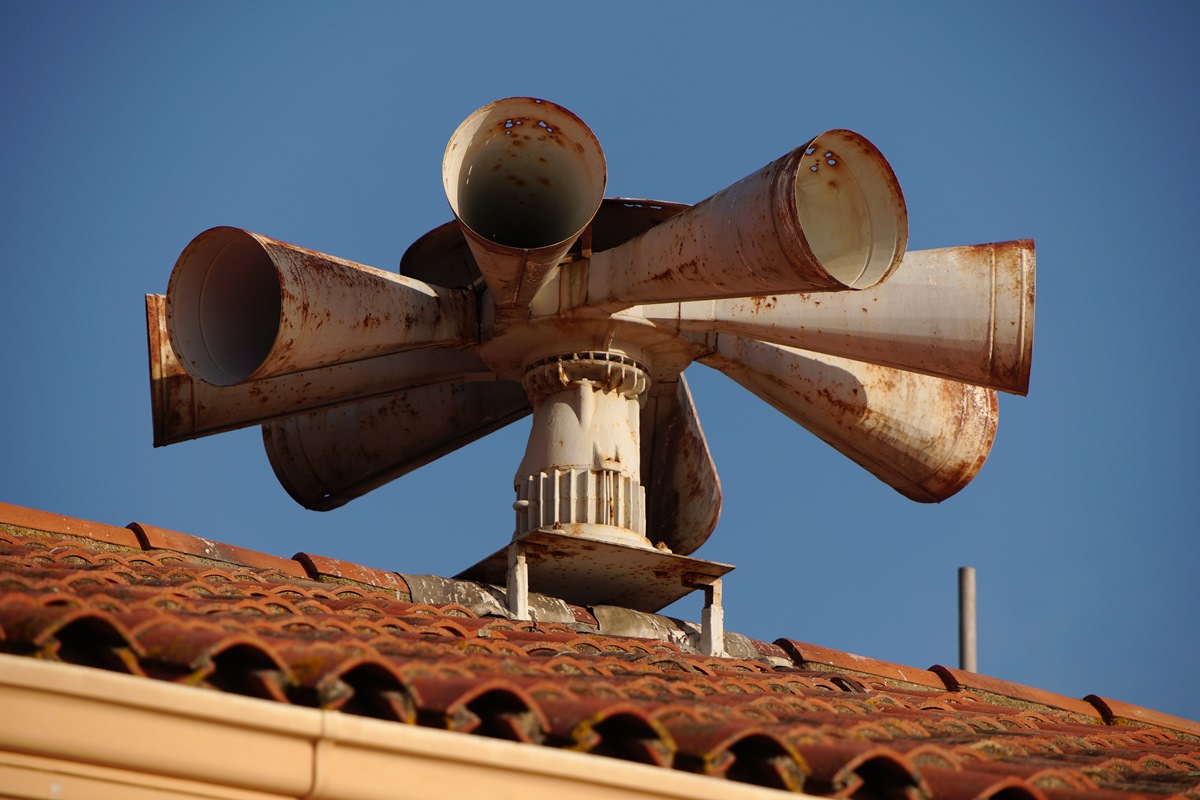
[263,381,529,511]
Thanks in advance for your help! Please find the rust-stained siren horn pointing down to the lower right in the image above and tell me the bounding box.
[700,335,1000,503]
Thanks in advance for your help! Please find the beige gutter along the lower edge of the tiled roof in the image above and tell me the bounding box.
[0,655,811,800]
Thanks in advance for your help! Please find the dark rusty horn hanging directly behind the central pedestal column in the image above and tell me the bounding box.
[641,375,721,555]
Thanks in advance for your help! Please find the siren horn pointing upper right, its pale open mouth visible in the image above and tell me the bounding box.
[588,130,908,307]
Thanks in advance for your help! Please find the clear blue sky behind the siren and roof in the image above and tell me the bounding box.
[0,2,1200,720]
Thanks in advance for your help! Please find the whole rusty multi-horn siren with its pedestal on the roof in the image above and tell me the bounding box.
[146,97,1034,651]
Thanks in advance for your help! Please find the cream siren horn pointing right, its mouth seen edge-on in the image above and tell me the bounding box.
[643,239,1036,395]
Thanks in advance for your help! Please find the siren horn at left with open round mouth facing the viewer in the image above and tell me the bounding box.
[167,228,479,386]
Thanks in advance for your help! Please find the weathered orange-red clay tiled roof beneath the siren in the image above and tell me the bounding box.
[7,504,1200,800]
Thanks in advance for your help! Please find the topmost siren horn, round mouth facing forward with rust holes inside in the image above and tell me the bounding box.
[442,97,607,307]
